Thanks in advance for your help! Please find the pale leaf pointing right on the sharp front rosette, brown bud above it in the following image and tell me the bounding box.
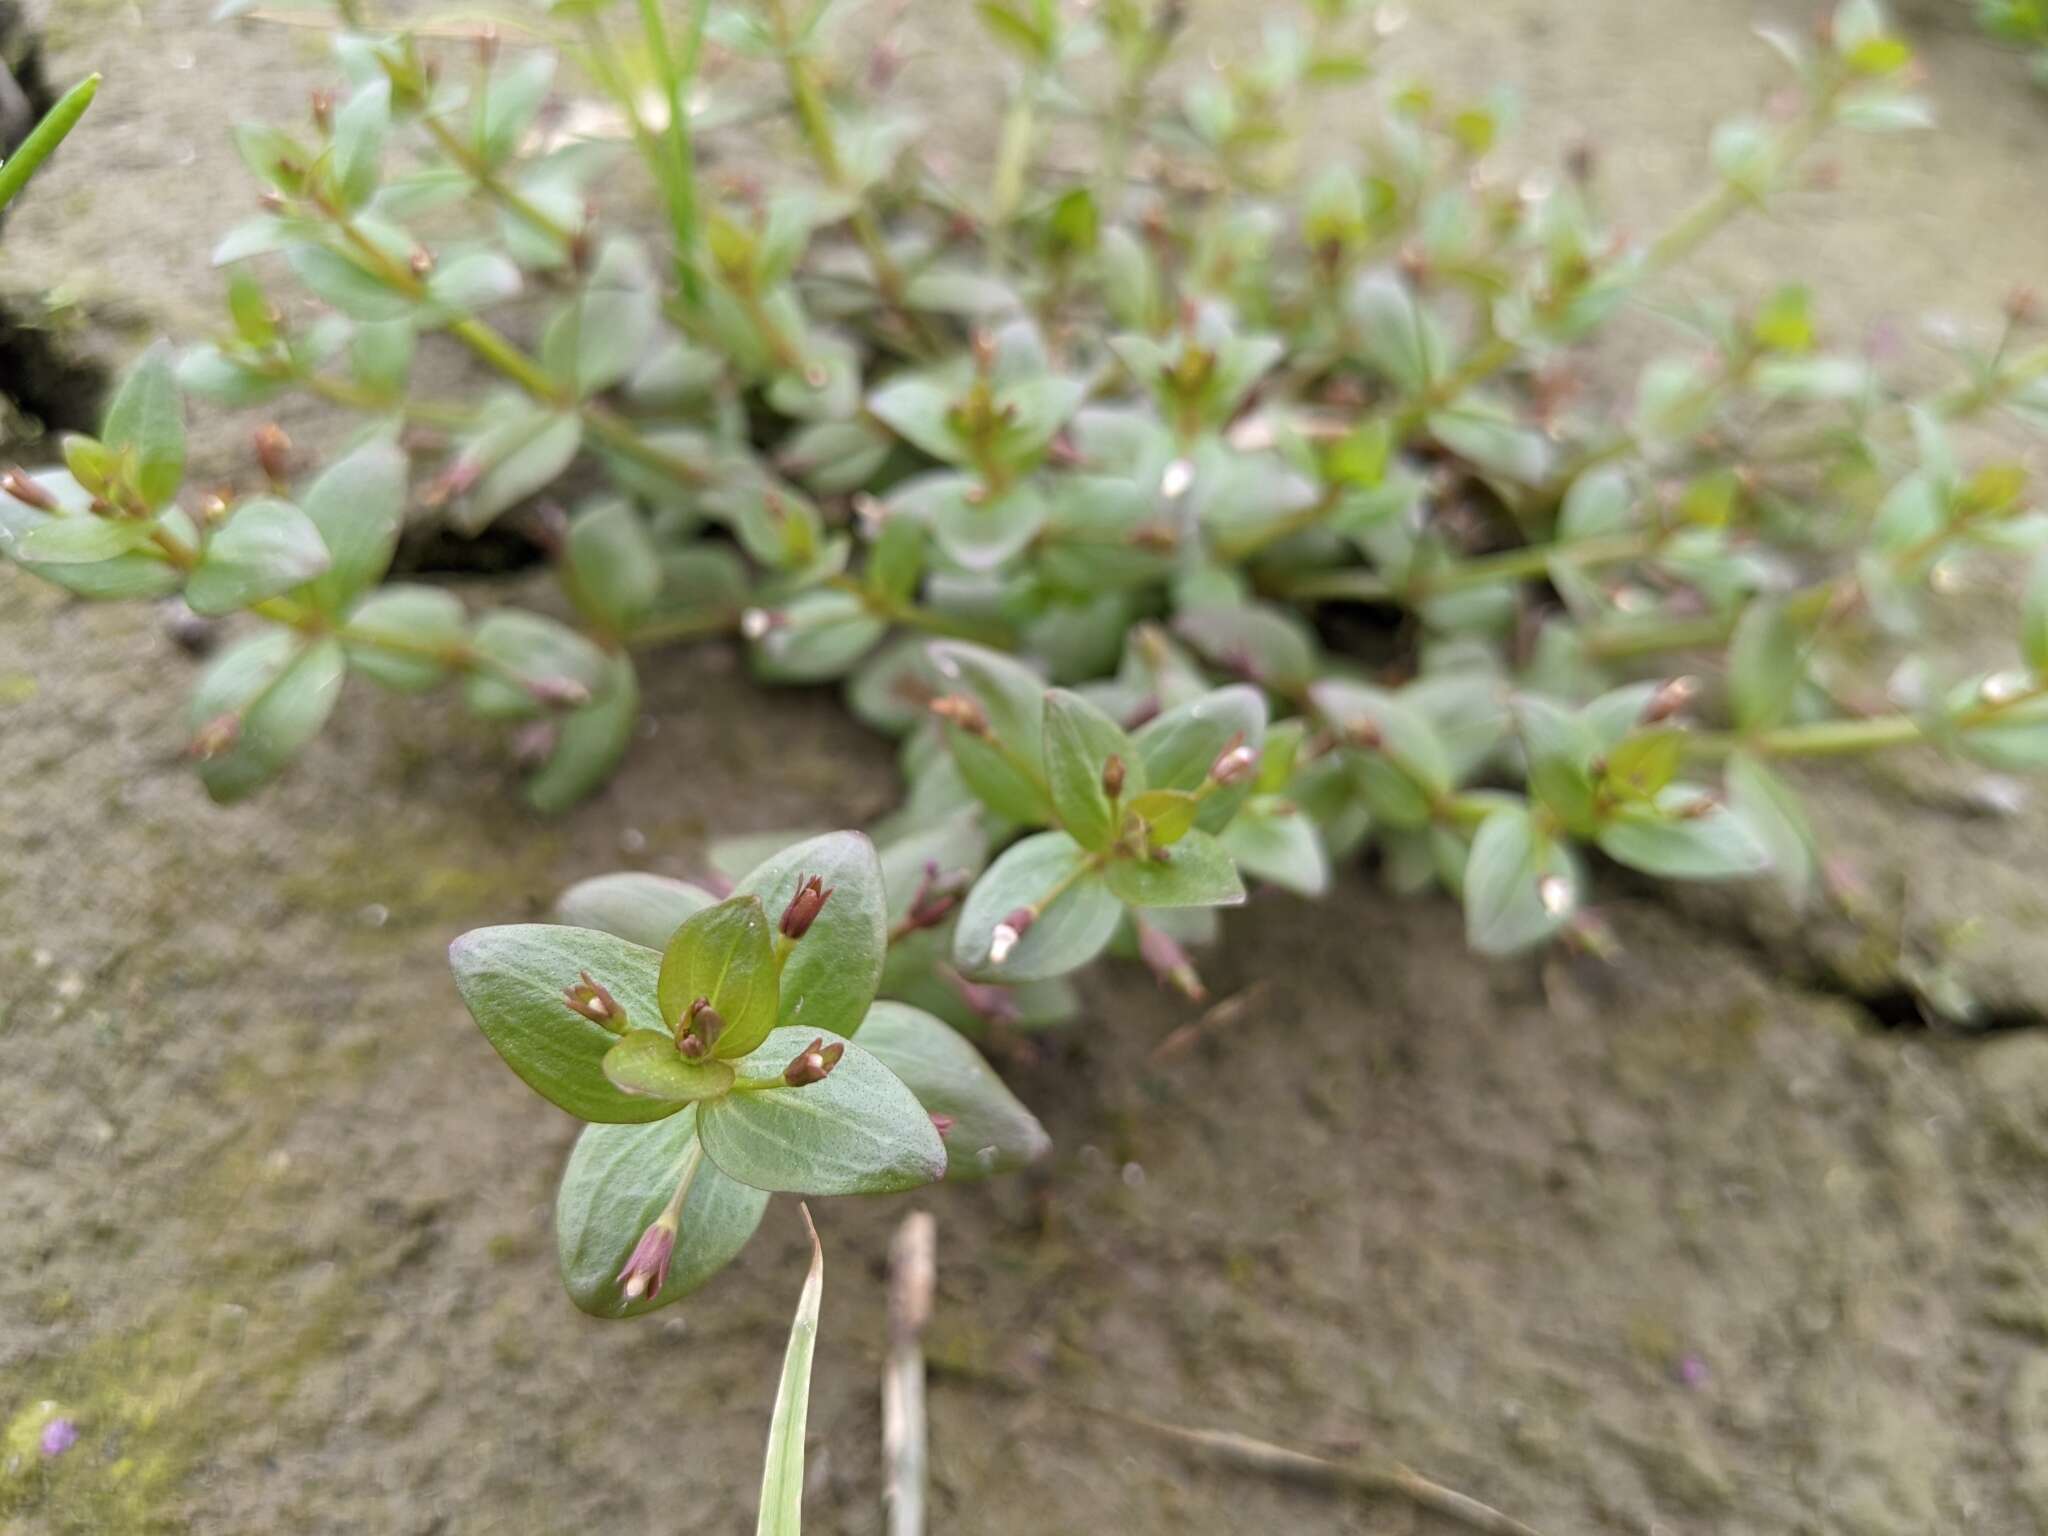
[696,1028,946,1194]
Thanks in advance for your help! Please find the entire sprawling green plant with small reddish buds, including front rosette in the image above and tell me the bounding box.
[0,0,2048,1315]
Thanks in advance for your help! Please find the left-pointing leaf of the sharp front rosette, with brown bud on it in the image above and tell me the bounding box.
[449,924,678,1124]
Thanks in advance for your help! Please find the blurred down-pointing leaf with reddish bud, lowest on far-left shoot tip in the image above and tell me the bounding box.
[190,629,348,805]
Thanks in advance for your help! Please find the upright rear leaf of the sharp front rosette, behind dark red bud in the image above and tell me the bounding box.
[733,831,889,1034]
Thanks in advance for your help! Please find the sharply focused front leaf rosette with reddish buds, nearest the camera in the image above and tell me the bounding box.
[451,834,1047,1317]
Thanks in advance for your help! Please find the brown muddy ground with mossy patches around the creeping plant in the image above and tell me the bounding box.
[0,0,2048,1536]
